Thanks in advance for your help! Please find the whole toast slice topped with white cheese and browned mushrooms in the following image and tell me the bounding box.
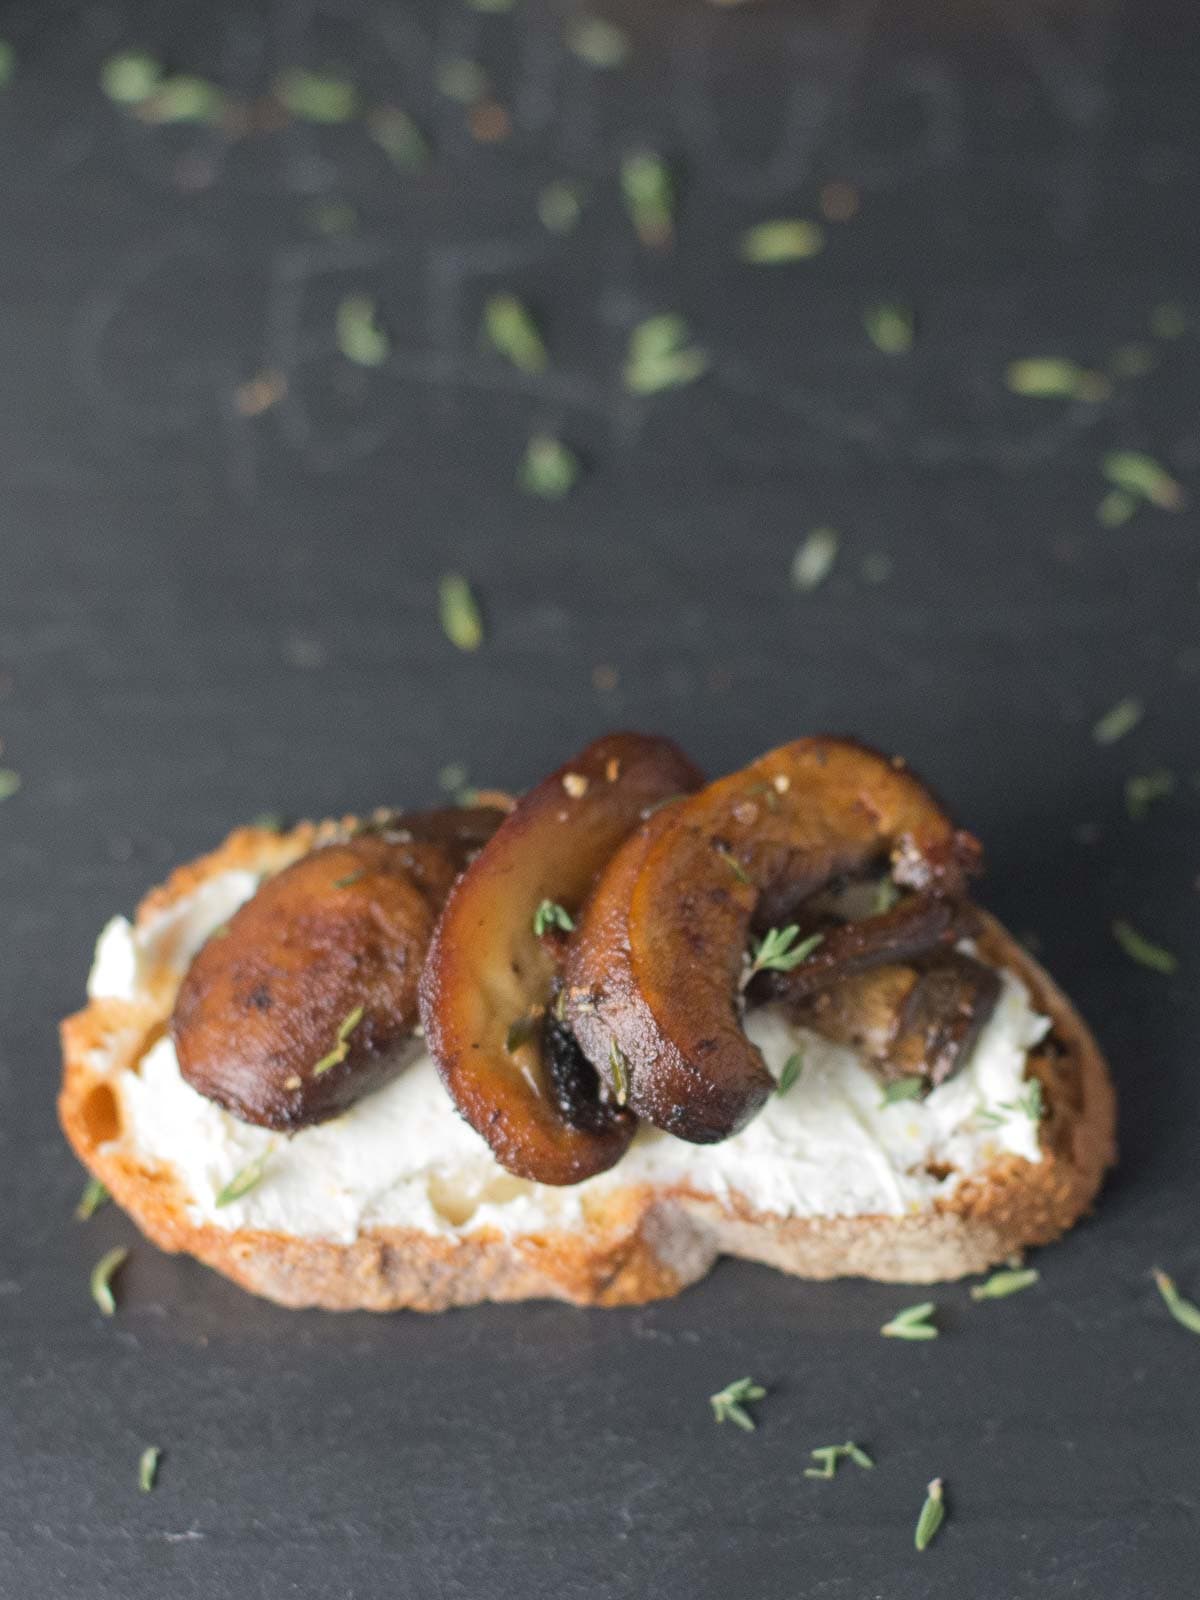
[59,734,1114,1310]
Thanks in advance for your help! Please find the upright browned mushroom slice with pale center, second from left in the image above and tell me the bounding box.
[421,733,701,1184]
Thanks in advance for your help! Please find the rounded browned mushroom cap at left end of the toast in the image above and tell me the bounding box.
[171,810,501,1130]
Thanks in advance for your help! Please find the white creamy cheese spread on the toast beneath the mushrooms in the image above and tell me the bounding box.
[88,872,1050,1243]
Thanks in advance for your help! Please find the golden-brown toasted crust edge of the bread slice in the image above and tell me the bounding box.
[59,822,1115,1310]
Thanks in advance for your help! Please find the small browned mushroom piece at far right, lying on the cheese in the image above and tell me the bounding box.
[786,950,1000,1088]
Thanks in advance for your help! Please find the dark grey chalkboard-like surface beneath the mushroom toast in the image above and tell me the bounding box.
[0,0,1200,1600]
